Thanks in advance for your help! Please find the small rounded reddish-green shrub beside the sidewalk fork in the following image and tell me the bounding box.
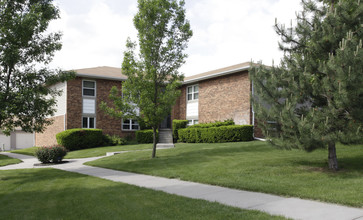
[35,145,67,163]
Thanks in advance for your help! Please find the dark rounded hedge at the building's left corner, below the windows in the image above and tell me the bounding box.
[56,128,104,151]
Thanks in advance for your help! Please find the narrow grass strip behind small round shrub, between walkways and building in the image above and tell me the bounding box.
[10,144,152,159]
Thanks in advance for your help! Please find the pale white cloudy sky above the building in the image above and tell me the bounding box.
[49,0,301,76]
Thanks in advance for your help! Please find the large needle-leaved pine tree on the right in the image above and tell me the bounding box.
[250,0,363,170]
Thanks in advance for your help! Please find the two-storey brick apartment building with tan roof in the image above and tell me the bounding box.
[35,62,261,146]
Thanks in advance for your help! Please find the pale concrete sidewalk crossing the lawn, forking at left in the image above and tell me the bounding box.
[0,153,363,220]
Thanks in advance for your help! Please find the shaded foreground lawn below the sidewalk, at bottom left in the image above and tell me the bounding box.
[0,168,284,220]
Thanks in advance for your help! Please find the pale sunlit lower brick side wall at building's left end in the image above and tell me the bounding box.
[35,115,64,147]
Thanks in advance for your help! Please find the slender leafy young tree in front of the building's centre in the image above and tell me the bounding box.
[101,0,193,158]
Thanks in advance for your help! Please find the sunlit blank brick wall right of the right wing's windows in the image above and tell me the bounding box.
[199,71,251,124]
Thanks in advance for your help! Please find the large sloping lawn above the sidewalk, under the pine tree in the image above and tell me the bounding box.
[86,141,363,207]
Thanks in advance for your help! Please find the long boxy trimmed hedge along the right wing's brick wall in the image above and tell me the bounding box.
[178,125,253,143]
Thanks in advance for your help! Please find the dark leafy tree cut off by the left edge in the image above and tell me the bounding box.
[0,0,73,135]
